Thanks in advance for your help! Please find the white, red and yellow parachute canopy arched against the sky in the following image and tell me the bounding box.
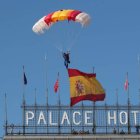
[32,9,90,33]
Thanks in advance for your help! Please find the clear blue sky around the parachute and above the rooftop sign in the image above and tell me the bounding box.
[0,0,140,136]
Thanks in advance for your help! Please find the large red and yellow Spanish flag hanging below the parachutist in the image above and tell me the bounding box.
[68,69,105,106]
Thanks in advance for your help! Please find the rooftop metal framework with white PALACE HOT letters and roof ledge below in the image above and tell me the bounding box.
[4,103,140,140]
